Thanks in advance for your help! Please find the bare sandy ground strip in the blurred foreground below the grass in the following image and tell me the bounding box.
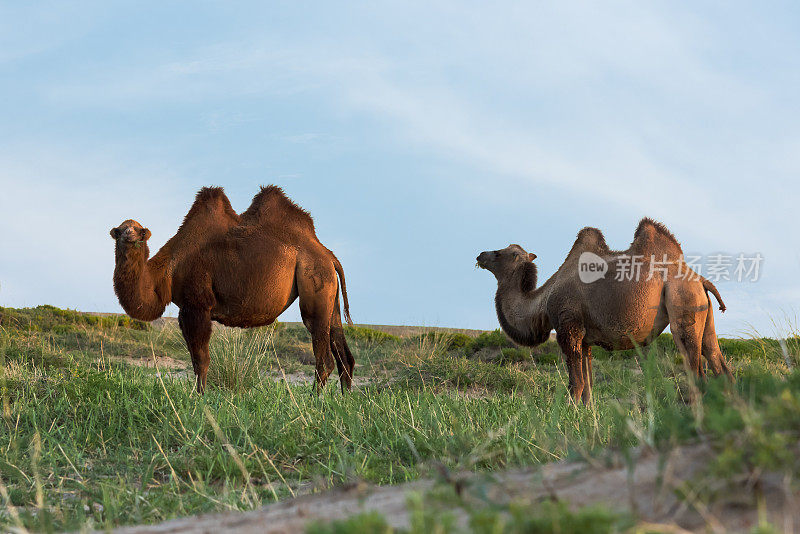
[109,445,800,534]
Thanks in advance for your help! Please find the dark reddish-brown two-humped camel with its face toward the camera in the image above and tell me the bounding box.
[111,186,355,393]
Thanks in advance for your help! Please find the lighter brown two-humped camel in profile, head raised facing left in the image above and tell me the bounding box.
[478,218,733,403]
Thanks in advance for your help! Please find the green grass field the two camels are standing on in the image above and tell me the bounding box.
[0,306,800,532]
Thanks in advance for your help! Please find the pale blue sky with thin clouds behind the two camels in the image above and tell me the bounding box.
[0,1,800,335]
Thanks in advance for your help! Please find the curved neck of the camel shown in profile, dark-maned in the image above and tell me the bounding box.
[494,264,552,347]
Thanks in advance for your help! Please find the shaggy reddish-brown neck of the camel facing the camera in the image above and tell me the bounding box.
[114,242,172,321]
